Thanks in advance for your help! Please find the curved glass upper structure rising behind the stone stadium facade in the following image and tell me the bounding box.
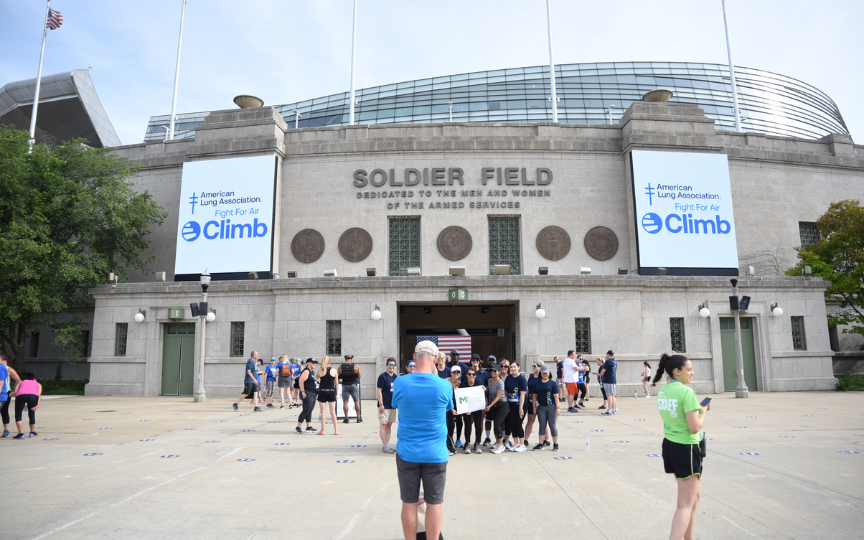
[144,62,849,142]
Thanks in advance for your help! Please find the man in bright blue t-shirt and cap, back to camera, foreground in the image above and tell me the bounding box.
[392,341,455,538]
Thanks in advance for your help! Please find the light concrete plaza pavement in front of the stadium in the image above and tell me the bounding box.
[0,389,864,540]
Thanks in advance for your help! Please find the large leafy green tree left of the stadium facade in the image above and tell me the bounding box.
[0,126,167,372]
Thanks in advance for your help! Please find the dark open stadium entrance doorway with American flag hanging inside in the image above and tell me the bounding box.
[396,303,519,373]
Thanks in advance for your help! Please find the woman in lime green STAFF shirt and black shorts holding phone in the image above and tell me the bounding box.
[652,354,711,540]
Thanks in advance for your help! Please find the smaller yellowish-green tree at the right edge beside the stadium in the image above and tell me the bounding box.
[786,200,864,336]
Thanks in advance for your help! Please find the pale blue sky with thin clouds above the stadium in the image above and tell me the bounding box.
[0,0,864,144]
